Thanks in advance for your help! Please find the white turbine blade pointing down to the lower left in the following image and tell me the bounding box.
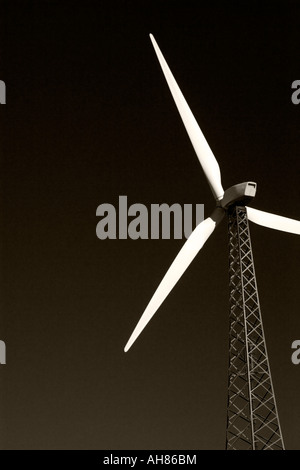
[124,208,224,352]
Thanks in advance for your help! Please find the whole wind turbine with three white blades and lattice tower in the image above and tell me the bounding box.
[125,34,300,450]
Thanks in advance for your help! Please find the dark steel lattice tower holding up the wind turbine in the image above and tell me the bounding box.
[226,206,284,450]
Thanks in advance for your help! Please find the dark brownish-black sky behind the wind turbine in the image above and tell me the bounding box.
[0,0,300,449]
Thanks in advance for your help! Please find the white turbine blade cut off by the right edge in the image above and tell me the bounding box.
[246,207,300,235]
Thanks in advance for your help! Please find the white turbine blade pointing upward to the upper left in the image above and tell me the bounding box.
[150,34,224,200]
